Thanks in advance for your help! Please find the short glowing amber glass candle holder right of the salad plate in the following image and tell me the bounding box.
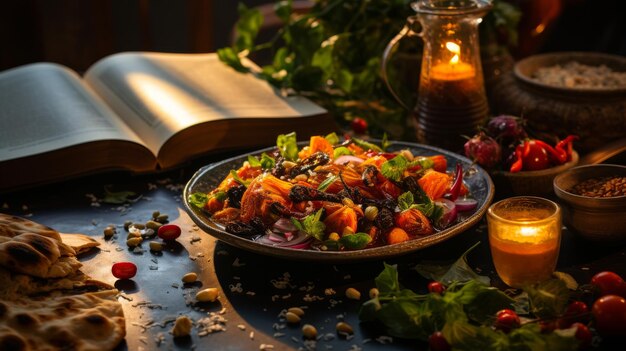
[487,196,561,288]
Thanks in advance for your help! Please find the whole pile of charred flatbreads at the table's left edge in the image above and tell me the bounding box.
[0,214,126,351]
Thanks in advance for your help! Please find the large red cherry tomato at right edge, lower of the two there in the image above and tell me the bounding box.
[591,295,626,337]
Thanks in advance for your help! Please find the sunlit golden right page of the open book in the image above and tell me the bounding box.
[85,53,326,154]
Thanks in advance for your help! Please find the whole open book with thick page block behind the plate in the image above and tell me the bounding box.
[0,52,335,190]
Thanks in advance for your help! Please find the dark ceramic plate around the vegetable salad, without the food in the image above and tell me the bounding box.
[183,142,494,262]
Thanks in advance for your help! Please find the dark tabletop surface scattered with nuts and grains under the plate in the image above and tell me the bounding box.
[0,160,626,350]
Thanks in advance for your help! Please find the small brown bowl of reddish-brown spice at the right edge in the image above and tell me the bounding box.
[553,164,626,242]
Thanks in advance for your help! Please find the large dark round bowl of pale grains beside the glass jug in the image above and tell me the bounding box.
[493,52,626,154]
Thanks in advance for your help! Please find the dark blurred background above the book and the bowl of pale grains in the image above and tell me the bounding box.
[0,0,626,72]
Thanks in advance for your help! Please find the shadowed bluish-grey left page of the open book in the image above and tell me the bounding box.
[0,63,141,161]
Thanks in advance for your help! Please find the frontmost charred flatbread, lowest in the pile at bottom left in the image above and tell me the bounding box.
[0,290,126,351]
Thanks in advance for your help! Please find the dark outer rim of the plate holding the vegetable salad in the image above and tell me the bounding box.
[183,139,495,262]
